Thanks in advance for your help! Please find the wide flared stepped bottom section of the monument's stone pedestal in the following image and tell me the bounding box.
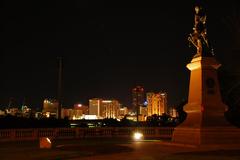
[172,102,240,146]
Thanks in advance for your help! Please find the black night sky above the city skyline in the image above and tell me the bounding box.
[0,0,240,107]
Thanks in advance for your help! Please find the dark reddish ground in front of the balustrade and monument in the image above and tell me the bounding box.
[0,138,240,160]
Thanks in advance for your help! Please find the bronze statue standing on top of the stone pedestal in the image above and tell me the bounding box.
[188,6,213,57]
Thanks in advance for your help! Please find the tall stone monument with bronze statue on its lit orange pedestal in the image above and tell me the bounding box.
[172,6,240,145]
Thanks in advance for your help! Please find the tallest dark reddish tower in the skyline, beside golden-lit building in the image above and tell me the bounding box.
[130,86,144,114]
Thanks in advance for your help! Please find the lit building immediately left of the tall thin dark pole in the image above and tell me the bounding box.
[42,99,59,118]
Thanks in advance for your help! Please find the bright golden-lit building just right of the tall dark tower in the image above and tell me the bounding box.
[147,92,167,116]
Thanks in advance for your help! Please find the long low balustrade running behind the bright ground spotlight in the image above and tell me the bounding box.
[0,127,174,141]
